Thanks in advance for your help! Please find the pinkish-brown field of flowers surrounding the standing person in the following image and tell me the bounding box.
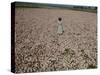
[15,8,97,73]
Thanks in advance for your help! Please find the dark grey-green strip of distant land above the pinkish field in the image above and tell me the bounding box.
[15,2,97,13]
